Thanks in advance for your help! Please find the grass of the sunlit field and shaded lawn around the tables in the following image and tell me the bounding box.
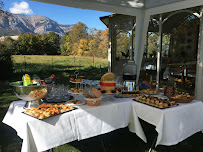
[0,55,203,152]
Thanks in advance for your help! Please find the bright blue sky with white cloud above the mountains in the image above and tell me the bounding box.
[2,0,112,30]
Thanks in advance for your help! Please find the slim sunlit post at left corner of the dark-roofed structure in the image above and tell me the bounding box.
[108,24,112,72]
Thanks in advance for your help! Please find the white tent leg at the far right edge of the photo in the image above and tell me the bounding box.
[195,7,203,101]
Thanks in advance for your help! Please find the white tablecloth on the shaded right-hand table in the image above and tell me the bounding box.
[129,100,203,146]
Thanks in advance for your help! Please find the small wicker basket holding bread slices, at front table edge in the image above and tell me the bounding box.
[83,88,102,106]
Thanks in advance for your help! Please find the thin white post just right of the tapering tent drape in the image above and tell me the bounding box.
[156,14,163,89]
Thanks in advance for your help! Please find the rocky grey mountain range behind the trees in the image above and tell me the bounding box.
[0,13,75,37]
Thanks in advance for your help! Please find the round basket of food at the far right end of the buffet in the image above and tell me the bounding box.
[170,93,195,103]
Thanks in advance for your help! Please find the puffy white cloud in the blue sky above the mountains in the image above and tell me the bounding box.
[10,1,33,14]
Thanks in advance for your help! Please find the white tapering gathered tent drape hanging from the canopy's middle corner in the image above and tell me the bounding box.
[134,11,150,83]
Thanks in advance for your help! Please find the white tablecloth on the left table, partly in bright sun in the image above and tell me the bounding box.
[3,99,132,152]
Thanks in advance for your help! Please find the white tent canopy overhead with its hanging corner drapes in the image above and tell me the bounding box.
[30,0,203,100]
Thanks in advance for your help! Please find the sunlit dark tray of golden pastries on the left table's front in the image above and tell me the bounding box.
[24,103,75,120]
